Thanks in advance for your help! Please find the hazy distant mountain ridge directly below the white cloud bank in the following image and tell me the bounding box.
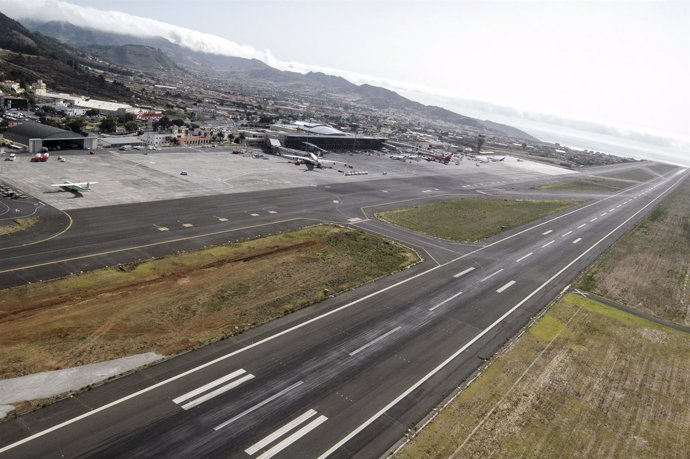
[20,21,536,140]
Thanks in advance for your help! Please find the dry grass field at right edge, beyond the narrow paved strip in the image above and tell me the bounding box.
[579,178,690,325]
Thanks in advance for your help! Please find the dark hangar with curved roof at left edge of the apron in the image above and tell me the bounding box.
[4,121,98,153]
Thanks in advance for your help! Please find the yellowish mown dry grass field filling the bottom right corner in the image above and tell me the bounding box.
[397,294,690,459]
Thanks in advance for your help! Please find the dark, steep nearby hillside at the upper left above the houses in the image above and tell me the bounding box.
[0,13,132,100]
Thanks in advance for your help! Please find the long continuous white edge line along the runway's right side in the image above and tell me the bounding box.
[318,172,678,459]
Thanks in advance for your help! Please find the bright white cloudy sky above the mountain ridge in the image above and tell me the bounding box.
[0,0,690,162]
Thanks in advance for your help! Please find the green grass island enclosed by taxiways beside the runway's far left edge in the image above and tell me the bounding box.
[376,199,580,242]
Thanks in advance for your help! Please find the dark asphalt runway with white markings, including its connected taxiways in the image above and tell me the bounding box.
[0,157,686,458]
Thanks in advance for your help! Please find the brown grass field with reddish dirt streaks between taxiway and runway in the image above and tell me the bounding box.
[0,225,418,379]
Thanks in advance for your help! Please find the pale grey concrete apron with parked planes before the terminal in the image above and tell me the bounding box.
[0,148,574,210]
